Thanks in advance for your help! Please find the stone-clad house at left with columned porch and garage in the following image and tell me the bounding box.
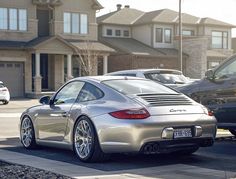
[0,0,114,97]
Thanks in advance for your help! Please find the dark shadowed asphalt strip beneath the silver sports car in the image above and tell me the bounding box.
[0,137,236,178]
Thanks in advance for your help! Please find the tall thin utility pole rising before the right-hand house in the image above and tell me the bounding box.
[179,0,183,72]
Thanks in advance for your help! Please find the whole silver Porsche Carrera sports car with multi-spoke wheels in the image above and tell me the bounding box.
[20,76,216,162]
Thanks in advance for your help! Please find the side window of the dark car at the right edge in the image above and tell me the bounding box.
[215,57,236,79]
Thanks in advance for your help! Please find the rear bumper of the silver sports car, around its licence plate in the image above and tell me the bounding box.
[92,114,217,153]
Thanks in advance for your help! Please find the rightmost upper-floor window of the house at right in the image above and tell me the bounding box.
[212,31,228,49]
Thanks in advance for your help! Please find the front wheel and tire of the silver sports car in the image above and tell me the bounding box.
[20,116,37,149]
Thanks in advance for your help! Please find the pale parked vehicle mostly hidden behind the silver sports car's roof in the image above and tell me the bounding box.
[106,69,195,88]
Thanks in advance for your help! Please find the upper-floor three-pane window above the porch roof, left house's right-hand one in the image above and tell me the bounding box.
[64,12,88,34]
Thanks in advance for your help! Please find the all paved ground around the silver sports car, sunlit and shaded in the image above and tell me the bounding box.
[0,100,236,179]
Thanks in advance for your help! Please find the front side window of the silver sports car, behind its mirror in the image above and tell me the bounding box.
[54,81,84,105]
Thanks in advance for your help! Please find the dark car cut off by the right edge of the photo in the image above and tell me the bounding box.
[178,55,236,136]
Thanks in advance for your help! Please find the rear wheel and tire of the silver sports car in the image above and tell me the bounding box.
[73,116,109,162]
